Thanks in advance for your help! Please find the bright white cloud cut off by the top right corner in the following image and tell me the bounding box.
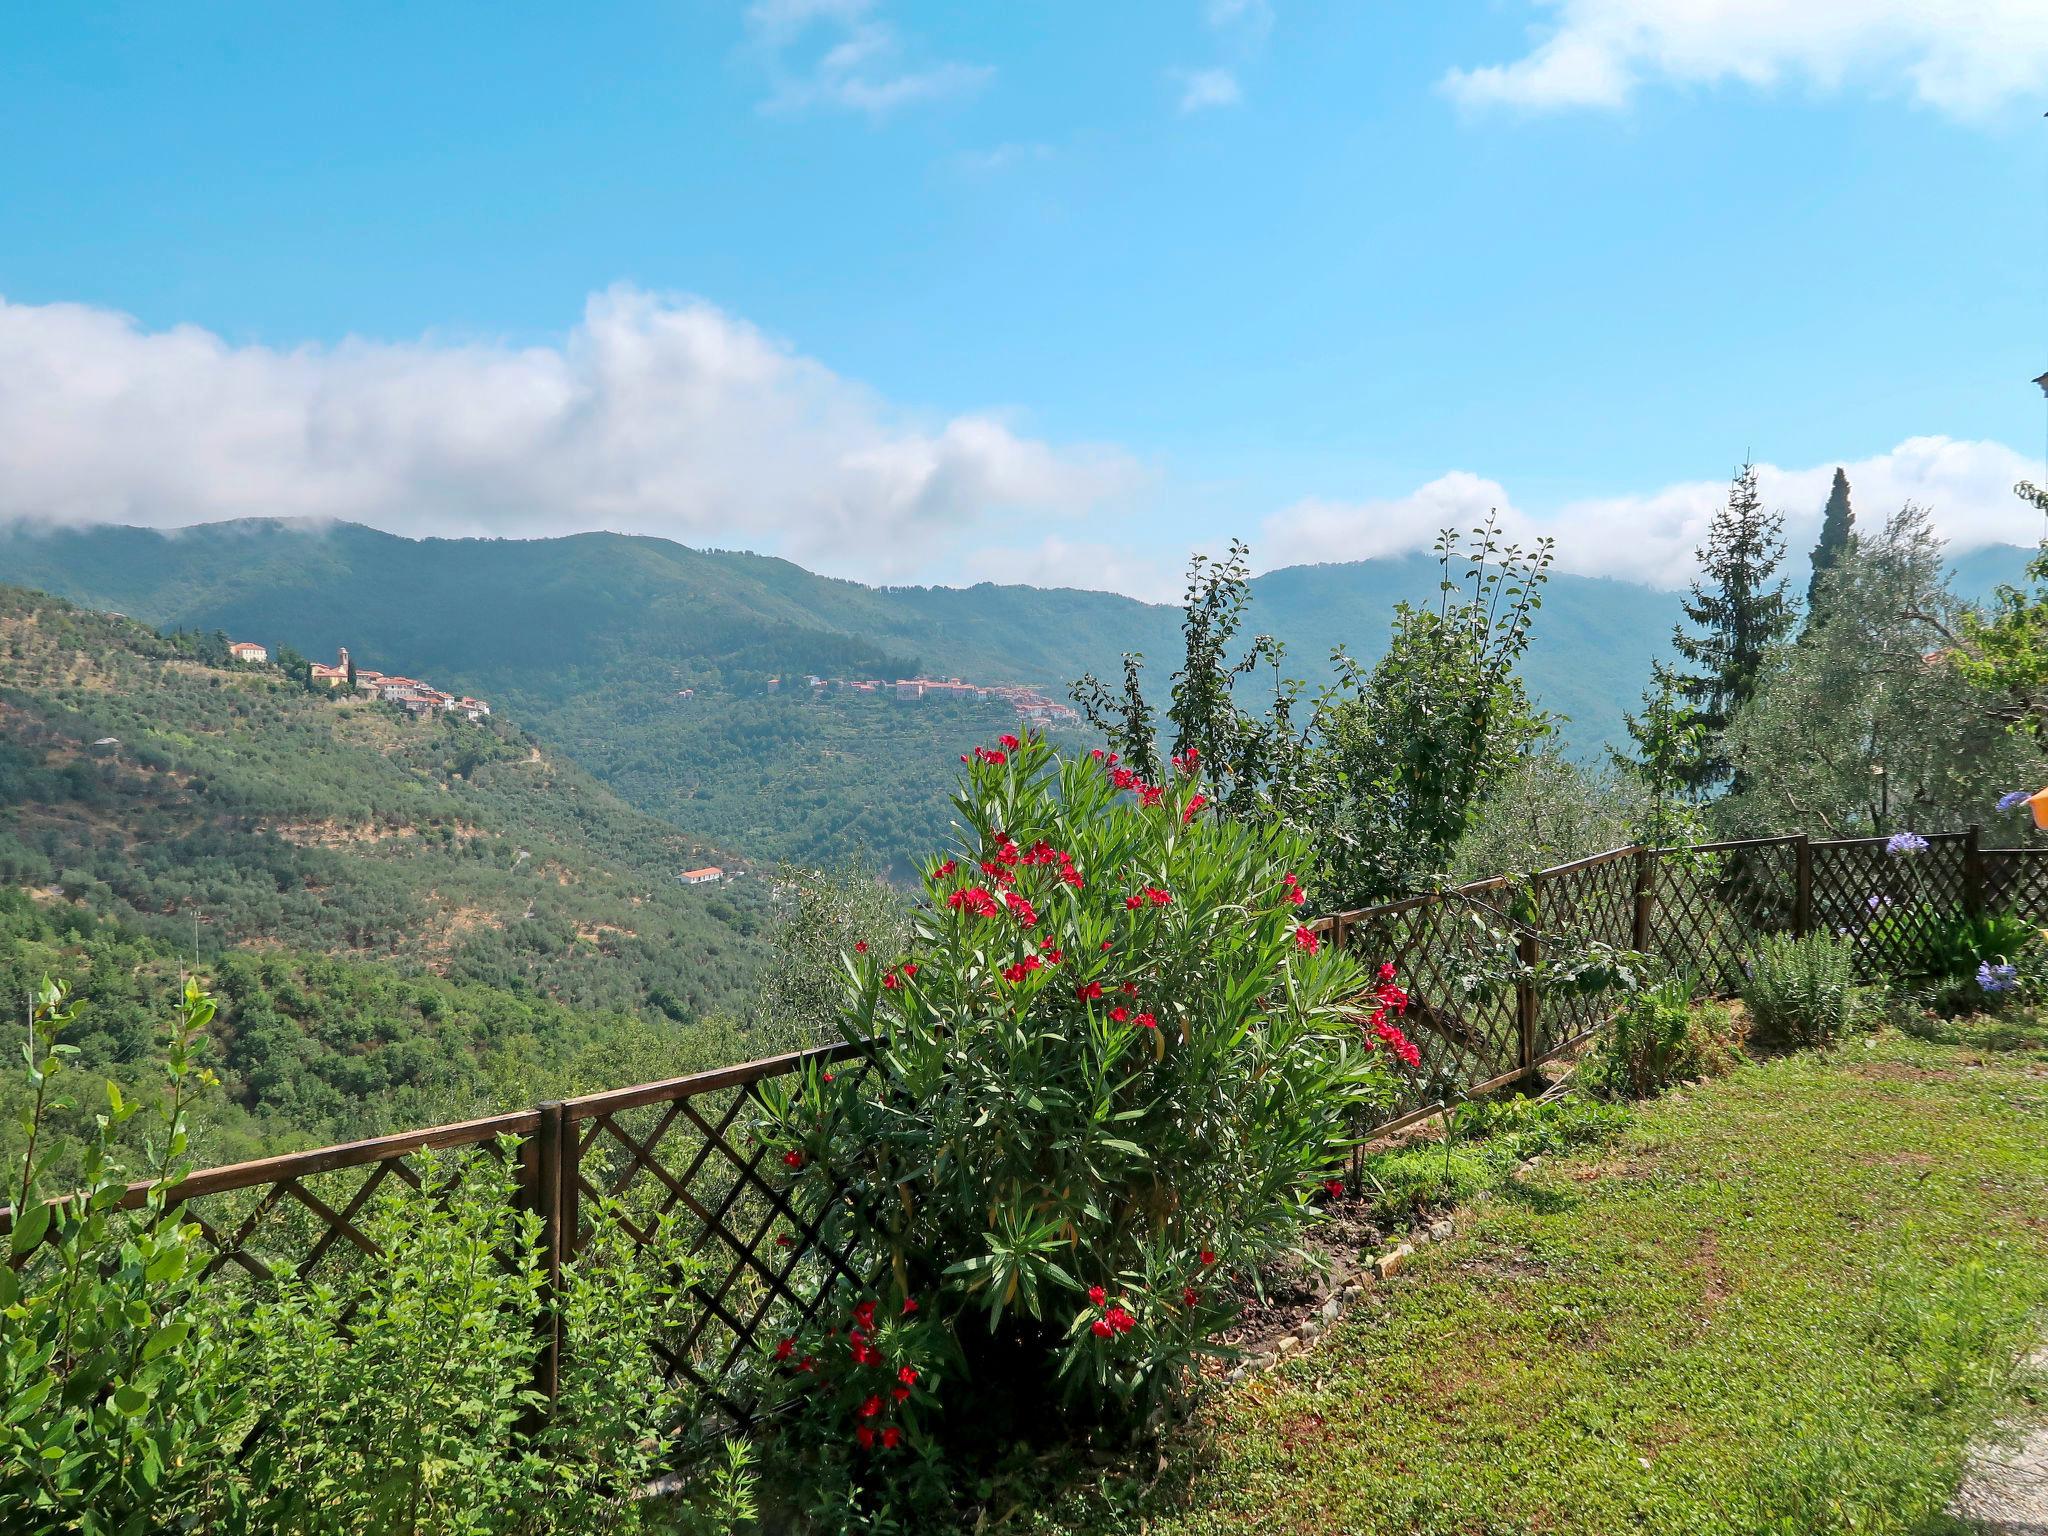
[1442,0,2048,117]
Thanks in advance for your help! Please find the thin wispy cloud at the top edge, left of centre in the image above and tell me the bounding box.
[748,0,995,117]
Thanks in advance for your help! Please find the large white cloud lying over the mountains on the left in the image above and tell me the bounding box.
[0,287,1145,580]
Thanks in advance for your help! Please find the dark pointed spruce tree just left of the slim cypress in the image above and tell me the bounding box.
[1628,465,1794,797]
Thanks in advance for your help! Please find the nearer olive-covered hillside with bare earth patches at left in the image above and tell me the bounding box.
[0,588,770,1022]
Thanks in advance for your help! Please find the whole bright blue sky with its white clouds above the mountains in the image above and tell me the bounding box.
[0,0,2048,590]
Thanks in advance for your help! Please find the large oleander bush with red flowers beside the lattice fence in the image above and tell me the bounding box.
[762,737,1411,1434]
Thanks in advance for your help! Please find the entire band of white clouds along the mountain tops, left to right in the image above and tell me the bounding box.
[0,287,2040,600]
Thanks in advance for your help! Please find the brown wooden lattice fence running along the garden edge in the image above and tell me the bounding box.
[0,829,2048,1413]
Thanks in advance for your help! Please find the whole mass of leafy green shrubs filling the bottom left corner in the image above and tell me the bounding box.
[0,983,752,1536]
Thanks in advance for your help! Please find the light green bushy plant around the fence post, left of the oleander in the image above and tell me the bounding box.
[240,1147,752,1536]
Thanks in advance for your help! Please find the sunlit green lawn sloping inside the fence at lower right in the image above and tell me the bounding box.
[1032,1030,2048,1536]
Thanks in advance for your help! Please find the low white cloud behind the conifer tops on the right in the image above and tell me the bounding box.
[1255,436,2040,586]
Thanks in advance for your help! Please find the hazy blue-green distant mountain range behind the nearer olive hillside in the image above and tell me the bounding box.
[0,520,2025,860]
